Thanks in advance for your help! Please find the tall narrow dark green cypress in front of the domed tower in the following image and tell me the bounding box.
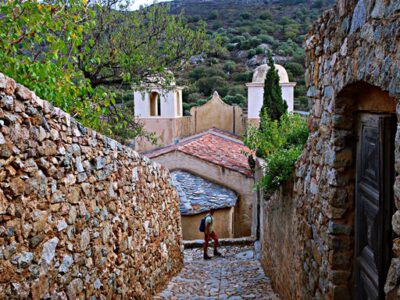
[260,51,288,120]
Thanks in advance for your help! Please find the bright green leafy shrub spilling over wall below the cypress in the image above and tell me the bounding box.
[244,111,308,193]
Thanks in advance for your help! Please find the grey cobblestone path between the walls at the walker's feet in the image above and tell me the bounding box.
[154,246,279,300]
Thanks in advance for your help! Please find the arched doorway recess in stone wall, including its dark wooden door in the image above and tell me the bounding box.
[334,82,396,299]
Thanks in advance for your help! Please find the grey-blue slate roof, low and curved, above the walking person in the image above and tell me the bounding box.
[171,170,237,216]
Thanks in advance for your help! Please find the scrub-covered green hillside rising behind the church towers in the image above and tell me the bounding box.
[169,0,333,112]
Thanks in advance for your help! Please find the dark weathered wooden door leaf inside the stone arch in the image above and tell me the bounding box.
[355,114,395,300]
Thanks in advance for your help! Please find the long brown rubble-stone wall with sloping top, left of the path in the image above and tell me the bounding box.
[0,73,182,299]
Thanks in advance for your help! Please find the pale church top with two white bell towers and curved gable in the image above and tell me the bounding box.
[134,64,296,152]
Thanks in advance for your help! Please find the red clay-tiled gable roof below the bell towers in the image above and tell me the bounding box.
[144,128,253,177]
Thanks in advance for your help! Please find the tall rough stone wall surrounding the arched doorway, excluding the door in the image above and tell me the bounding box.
[263,0,400,299]
